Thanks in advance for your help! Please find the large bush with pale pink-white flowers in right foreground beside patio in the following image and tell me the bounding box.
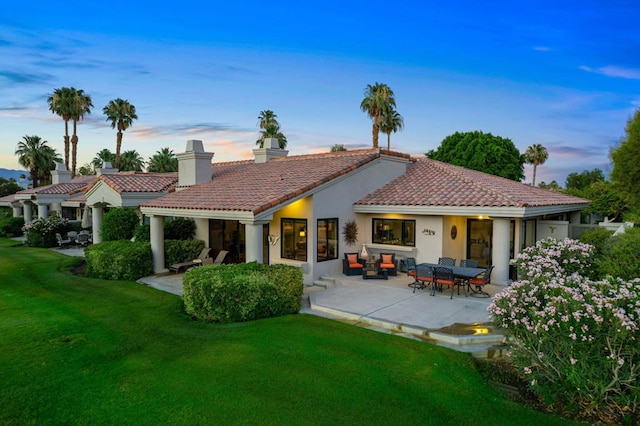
[489,239,640,423]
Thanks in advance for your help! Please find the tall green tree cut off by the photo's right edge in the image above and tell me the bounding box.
[610,108,640,209]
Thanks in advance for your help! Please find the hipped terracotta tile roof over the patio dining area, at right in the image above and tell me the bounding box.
[355,157,589,207]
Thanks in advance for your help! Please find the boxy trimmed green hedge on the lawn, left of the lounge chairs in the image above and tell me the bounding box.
[84,240,153,280]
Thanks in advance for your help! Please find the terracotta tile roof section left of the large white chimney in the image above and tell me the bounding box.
[85,172,178,194]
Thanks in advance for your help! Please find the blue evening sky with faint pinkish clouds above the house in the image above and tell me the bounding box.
[0,0,640,185]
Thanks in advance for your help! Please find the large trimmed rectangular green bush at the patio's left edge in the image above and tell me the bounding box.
[182,262,303,322]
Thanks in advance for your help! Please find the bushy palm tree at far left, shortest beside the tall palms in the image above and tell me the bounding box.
[15,135,62,188]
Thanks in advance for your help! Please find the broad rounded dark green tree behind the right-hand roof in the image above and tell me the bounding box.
[425,130,524,181]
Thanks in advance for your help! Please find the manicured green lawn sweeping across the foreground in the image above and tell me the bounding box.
[0,240,580,425]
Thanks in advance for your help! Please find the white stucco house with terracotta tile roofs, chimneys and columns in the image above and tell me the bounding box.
[5,139,589,284]
